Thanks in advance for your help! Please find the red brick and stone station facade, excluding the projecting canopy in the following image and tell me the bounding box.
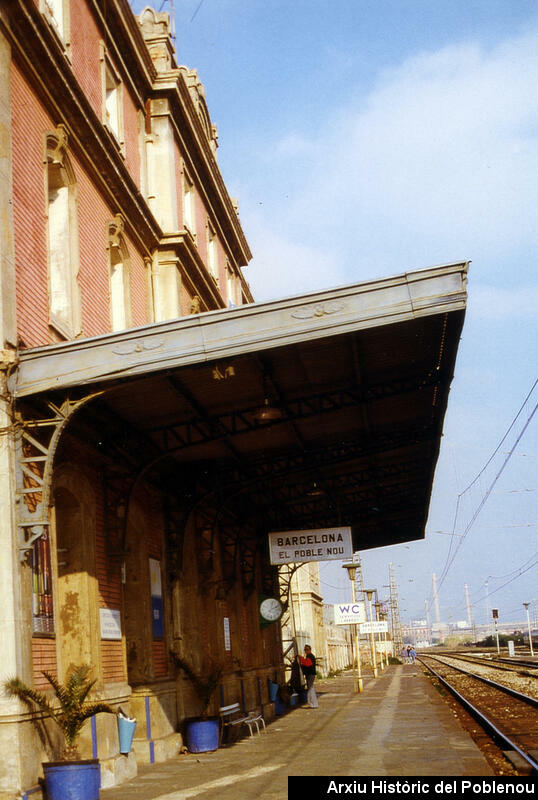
[0,0,280,797]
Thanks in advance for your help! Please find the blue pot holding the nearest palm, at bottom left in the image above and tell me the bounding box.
[43,758,101,800]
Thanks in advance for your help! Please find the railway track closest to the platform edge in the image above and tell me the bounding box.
[418,655,538,774]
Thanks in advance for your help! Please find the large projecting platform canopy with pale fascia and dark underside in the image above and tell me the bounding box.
[11,262,467,550]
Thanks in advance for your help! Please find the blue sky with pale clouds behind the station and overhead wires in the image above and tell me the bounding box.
[132,0,538,624]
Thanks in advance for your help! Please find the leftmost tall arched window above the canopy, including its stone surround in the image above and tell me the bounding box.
[46,125,80,339]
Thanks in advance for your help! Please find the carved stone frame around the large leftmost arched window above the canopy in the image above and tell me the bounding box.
[44,124,82,339]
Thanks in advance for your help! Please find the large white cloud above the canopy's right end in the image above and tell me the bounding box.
[244,31,538,300]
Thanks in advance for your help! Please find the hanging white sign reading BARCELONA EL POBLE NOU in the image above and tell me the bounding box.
[269,527,353,564]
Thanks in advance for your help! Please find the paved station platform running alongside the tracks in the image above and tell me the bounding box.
[101,664,493,800]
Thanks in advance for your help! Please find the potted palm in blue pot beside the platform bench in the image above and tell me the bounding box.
[171,652,222,753]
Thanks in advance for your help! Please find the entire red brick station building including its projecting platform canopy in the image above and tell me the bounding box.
[0,0,467,800]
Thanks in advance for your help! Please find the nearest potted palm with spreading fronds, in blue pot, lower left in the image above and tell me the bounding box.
[4,664,116,800]
